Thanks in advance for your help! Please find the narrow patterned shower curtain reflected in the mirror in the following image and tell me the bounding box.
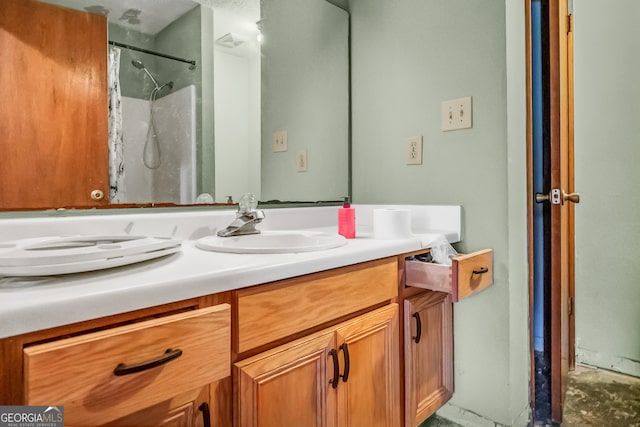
[108,46,125,203]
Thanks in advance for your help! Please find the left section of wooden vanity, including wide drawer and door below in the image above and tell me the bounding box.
[0,297,231,427]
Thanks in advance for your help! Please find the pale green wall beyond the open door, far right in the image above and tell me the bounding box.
[574,0,640,376]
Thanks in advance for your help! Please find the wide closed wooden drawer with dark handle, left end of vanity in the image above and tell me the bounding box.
[24,304,231,426]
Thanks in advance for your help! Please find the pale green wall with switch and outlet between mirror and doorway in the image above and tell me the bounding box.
[350,0,529,425]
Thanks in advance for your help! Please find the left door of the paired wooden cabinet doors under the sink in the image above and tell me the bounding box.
[235,333,336,427]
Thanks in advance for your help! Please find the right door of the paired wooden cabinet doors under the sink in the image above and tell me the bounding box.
[336,304,401,427]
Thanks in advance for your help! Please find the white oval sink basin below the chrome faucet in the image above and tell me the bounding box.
[196,230,347,254]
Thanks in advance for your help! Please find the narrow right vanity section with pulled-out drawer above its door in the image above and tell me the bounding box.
[398,249,493,427]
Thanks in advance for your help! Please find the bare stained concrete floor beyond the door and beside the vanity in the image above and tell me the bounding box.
[420,366,640,427]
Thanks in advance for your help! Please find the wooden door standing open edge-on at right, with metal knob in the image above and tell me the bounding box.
[549,0,579,422]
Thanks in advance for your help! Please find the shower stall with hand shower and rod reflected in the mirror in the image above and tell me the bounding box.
[109,8,202,204]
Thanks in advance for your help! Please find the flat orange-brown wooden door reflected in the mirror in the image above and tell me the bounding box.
[0,0,109,210]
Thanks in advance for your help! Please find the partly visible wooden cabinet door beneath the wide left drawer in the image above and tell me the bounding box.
[102,386,210,427]
